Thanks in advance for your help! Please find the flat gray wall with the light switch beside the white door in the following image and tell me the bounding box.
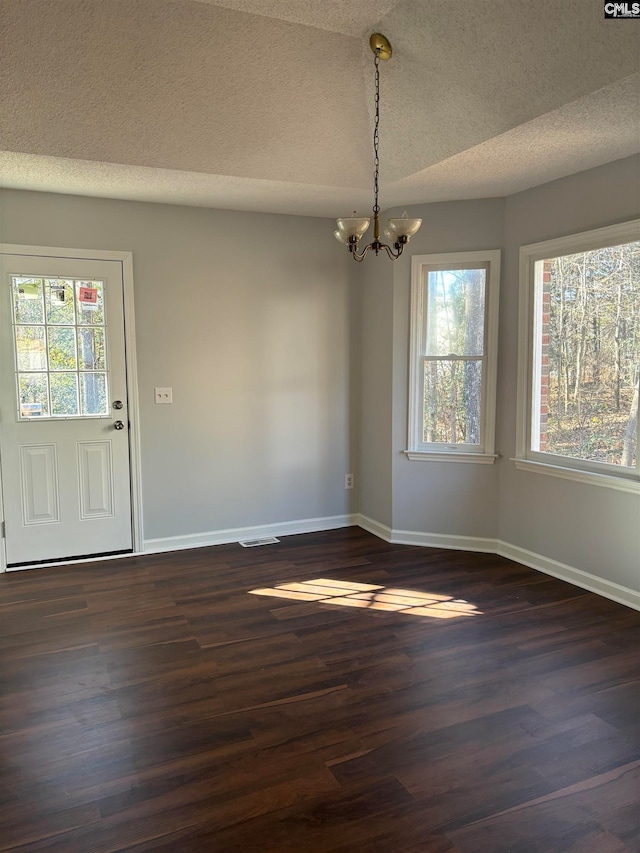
[0,190,355,539]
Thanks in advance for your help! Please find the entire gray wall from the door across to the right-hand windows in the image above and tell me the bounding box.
[0,157,640,588]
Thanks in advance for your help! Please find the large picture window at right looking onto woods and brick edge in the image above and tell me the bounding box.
[516,221,640,491]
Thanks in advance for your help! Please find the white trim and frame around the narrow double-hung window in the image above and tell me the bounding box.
[405,249,502,465]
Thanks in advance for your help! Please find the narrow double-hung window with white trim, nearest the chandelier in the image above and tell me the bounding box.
[406,250,500,463]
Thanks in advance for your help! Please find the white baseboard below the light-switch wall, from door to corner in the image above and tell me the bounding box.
[144,515,358,554]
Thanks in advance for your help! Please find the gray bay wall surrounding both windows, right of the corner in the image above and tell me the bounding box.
[360,157,640,589]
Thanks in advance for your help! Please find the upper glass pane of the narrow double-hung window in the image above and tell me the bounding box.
[426,269,487,356]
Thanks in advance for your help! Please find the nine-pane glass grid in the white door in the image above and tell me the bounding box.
[11,275,109,420]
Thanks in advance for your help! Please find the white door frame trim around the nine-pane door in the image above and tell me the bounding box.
[0,243,144,572]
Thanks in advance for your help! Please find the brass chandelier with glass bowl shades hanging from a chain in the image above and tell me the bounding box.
[333,33,422,261]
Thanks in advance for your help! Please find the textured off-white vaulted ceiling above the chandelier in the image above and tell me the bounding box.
[0,0,640,216]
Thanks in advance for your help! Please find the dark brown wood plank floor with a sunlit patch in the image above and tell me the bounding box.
[0,528,640,853]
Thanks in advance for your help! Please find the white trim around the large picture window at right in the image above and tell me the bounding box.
[512,219,640,494]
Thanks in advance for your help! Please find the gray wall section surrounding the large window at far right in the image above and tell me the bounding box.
[498,157,640,589]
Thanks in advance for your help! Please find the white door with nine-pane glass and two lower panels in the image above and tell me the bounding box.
[0,254,132,568]
